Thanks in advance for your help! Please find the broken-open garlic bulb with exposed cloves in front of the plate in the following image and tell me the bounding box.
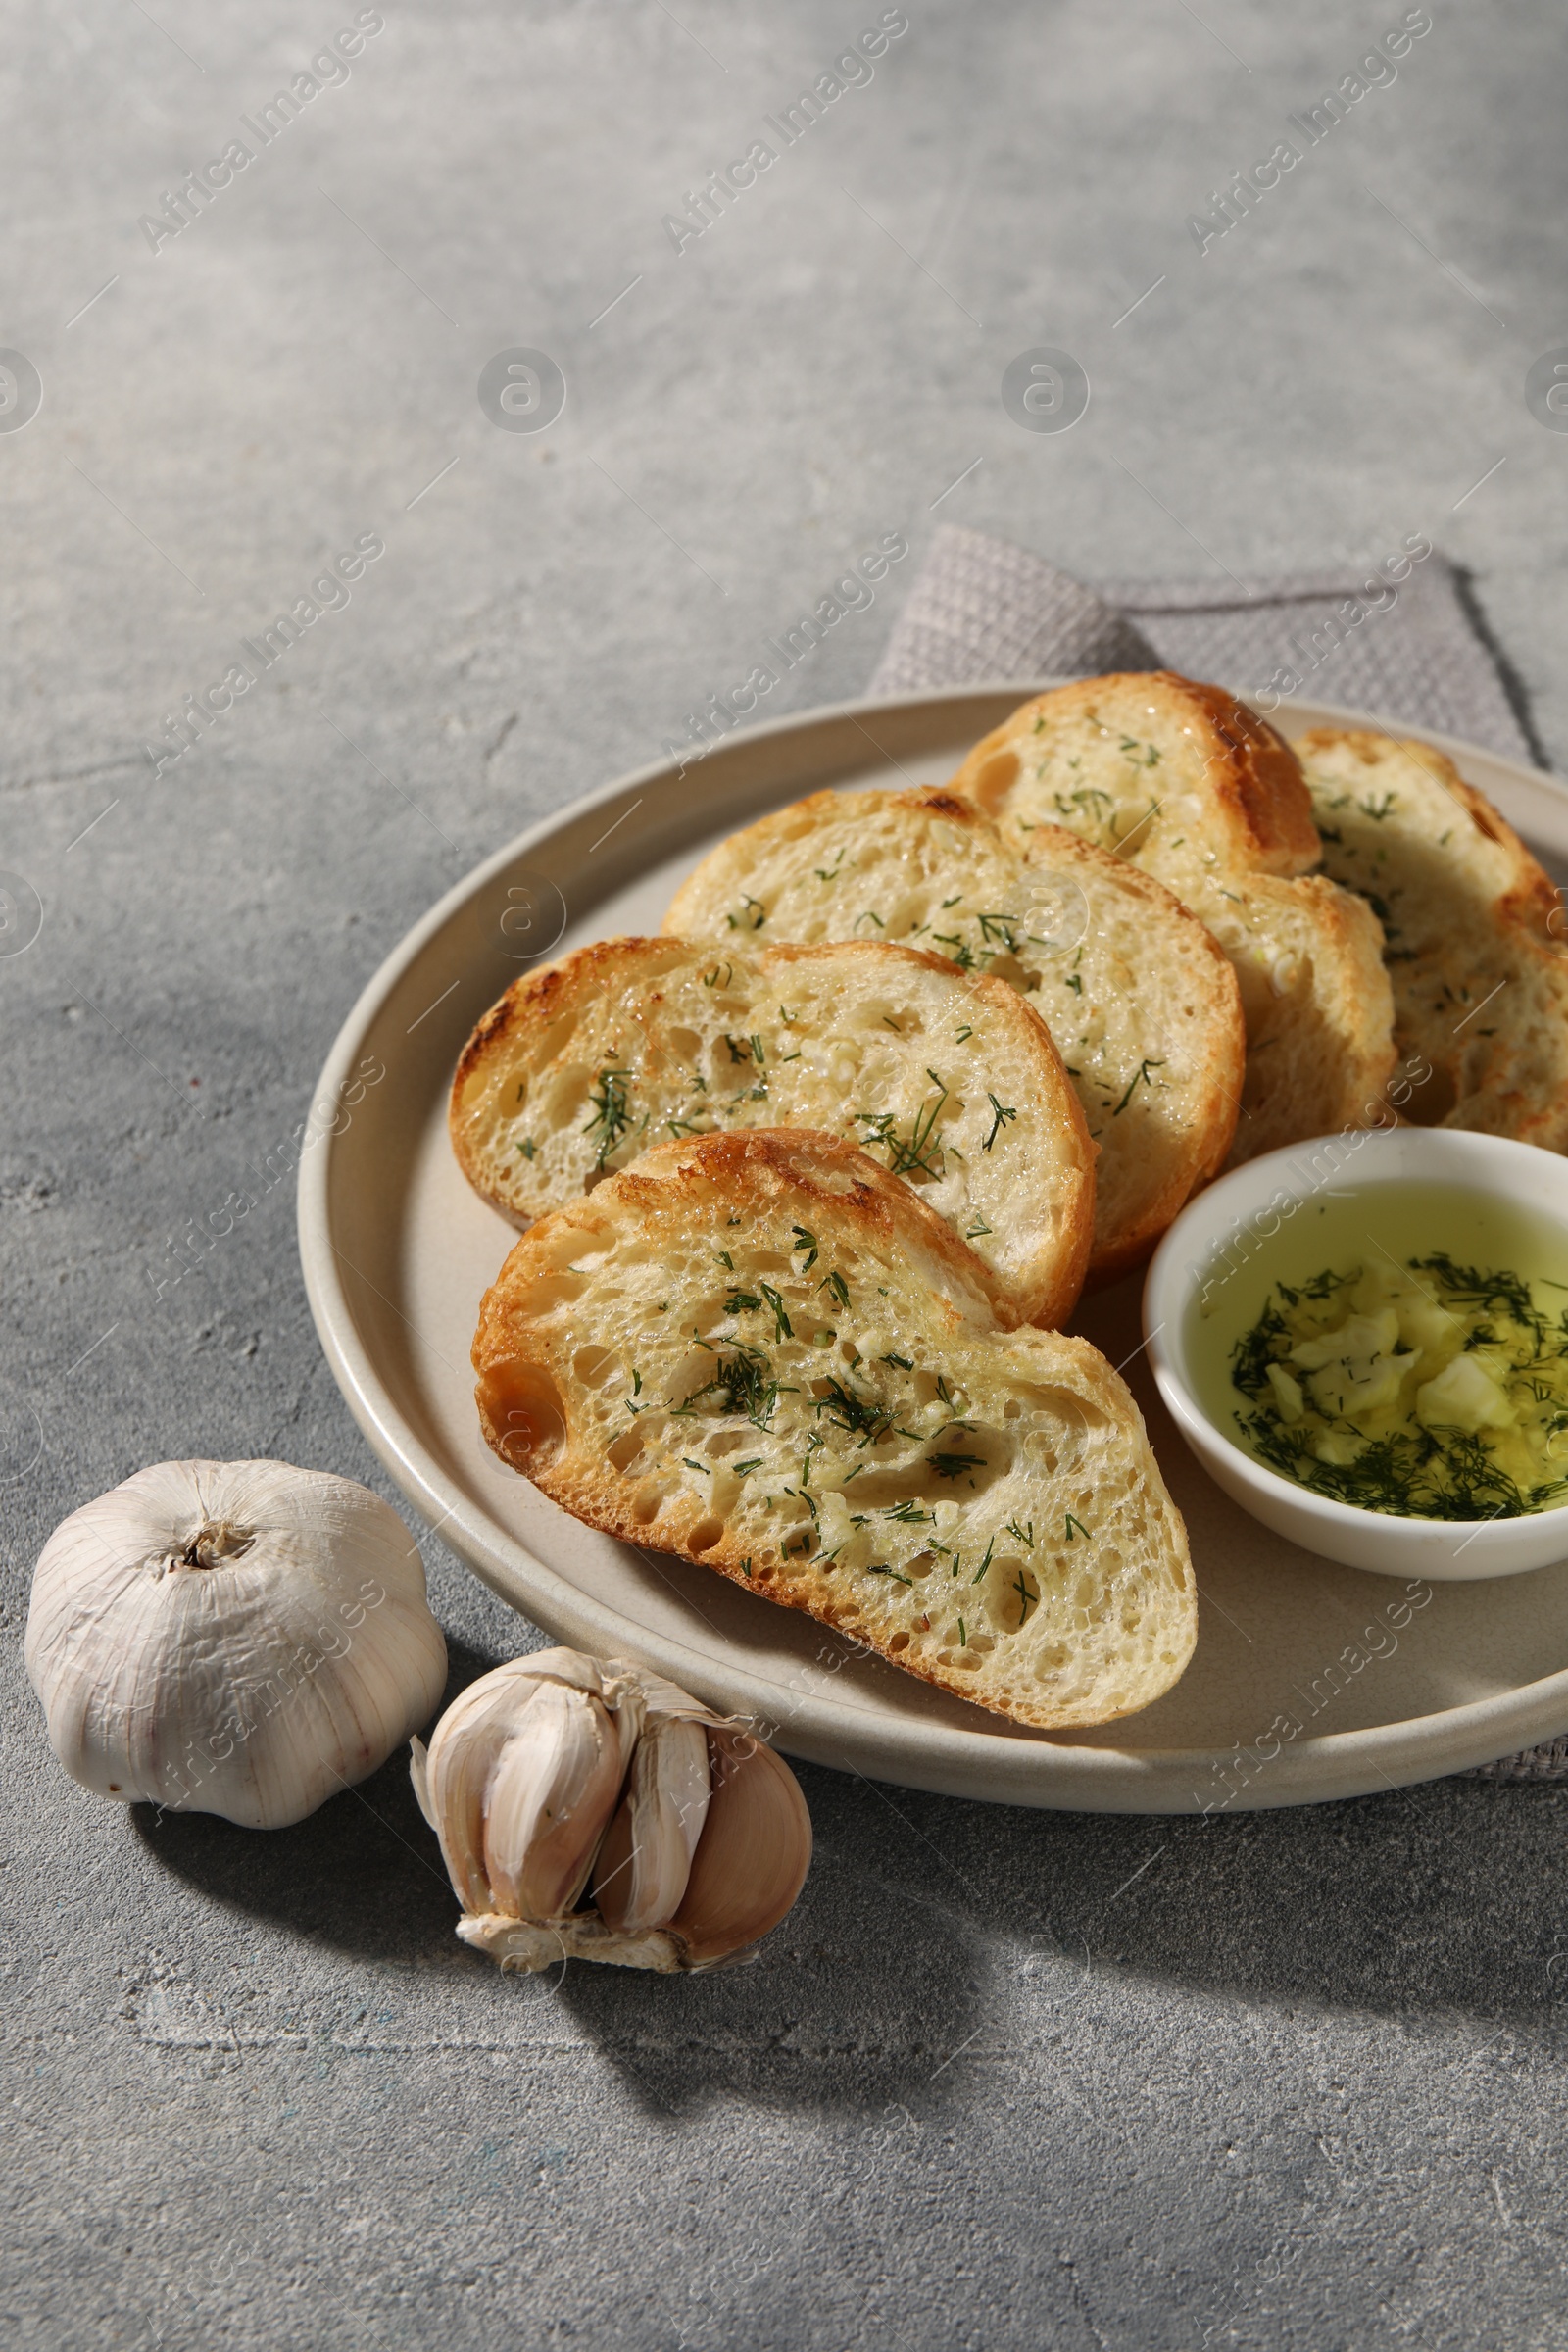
[414,1648,811,1974]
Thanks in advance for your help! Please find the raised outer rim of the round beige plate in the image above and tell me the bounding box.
[296,677,1568,1816]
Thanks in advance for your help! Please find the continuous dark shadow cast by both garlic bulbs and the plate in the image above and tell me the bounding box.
[131,1644,1568,2129]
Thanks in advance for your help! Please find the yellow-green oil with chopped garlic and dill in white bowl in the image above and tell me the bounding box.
[1183,1176,1568,1550]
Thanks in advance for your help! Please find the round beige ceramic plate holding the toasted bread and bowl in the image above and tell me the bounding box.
[299,680,1568,1813]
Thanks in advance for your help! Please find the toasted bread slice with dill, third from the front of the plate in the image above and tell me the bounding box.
[665,790,1246,1282]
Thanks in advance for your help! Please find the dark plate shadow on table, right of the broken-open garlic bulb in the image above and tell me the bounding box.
[808,1774,1568,2018]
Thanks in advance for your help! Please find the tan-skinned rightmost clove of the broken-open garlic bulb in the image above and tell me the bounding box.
[670,1724,811,1969]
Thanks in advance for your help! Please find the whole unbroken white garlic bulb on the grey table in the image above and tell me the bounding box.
[25,1460,447,1830]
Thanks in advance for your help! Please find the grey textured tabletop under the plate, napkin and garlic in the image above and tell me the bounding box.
[0,0,1568,2352]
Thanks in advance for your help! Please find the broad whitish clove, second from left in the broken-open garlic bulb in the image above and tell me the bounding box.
[484,1680,623,1919]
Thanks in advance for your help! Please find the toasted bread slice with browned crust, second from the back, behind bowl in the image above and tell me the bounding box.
[953,670,1394,1162]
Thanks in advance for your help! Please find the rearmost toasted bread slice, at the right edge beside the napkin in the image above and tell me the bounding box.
[1298,727,1568,1152]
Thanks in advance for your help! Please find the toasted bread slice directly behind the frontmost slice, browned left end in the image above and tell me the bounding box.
[452,939,1096,1324]
